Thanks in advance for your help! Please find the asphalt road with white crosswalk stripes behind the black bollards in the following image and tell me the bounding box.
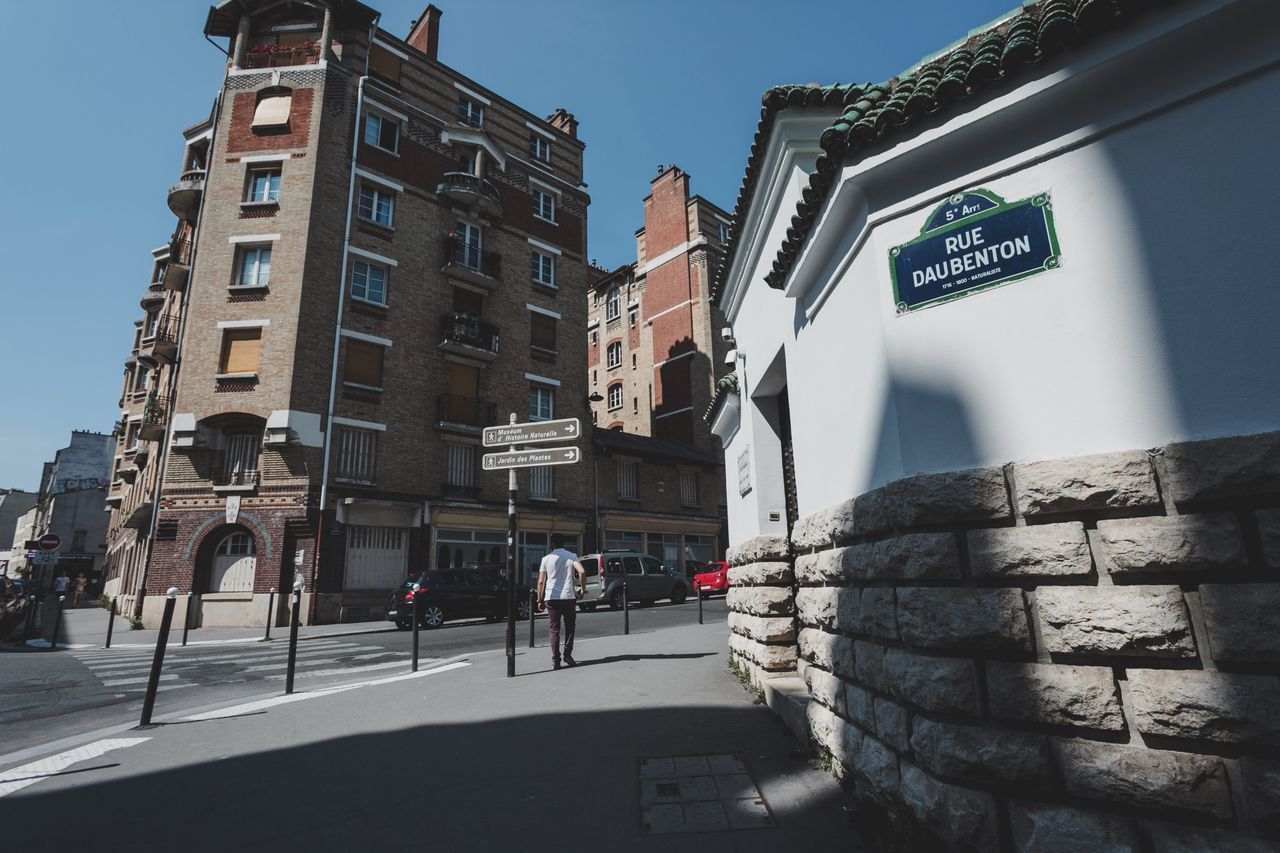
[0,597,726,753]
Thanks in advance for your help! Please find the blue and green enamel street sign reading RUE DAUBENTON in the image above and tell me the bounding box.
[888,190,1061,314]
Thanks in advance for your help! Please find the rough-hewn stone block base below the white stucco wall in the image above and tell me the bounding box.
[783,433,1280,853]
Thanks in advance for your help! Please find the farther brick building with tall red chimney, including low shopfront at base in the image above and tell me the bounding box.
[588,167,730,564]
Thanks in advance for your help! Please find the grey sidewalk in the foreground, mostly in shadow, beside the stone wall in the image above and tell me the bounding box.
[0,614,863,853]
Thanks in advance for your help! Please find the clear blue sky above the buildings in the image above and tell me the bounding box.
[0,0,1016,489]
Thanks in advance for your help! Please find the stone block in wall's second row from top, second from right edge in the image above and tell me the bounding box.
[1098,512,1247,575]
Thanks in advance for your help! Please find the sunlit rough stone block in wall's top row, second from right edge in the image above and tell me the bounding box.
[1014,451,1160,516]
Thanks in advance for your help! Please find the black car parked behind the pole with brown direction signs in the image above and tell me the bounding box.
[387,569,529,630]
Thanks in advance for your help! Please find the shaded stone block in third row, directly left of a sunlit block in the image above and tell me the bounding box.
[897,587,1032,653]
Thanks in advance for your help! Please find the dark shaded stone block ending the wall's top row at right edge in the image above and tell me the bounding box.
[1165,433,1280,503]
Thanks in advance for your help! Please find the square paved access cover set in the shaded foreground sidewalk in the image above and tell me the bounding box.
[636,753,777,835]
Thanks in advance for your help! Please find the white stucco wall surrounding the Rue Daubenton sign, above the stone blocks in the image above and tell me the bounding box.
[726,0,1280,542]
